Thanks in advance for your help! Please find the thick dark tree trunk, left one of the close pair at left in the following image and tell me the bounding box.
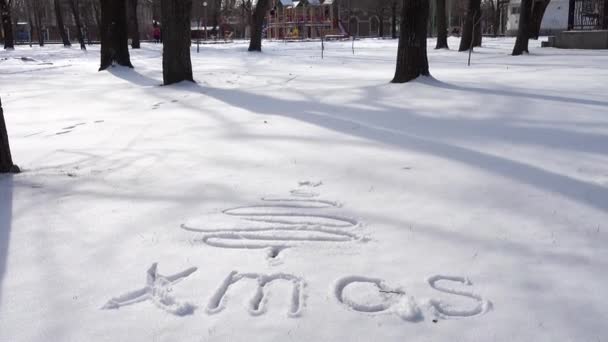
[99,0,133,71]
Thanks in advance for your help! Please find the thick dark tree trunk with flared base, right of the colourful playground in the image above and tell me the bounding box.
[392,0,430,83]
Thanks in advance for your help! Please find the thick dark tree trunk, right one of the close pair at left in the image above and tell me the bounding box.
[160,0,194,85]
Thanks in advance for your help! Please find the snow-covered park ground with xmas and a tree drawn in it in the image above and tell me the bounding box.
[0,39,608,342]
